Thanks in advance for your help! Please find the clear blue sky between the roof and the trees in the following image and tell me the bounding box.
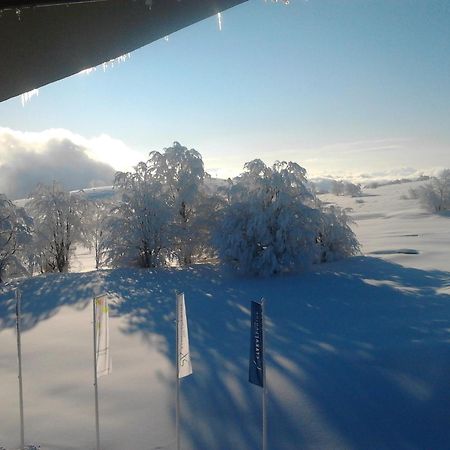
[0,0,450,176]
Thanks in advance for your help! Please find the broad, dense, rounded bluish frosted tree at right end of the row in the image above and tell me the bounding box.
[216,159,357,275]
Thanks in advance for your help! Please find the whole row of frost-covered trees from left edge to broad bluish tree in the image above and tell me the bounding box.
[0,142,359,281]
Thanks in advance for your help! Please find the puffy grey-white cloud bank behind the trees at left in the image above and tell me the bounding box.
[0,128,115,199]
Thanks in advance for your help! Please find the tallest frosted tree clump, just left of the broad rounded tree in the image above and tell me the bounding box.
[107,142,211,267]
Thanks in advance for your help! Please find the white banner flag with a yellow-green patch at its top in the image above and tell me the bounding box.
[94,295,112,377]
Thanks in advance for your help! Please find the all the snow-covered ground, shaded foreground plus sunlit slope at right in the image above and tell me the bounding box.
[0,180,450,450]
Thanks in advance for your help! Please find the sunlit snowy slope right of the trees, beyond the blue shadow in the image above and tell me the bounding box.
[320,181,450,271]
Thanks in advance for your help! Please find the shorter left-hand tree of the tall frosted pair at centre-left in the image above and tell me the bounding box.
[104,162,171,267]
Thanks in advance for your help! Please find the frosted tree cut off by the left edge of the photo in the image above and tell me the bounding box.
[0,194,32,284]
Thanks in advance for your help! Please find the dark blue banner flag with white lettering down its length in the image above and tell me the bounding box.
[248,301,264,387]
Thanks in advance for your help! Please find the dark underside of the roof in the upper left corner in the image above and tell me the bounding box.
[0,0,246,101]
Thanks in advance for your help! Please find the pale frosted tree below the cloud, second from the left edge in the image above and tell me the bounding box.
[25,183,88,272]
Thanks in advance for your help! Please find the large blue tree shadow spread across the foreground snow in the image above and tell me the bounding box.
[0,257,450,450]
